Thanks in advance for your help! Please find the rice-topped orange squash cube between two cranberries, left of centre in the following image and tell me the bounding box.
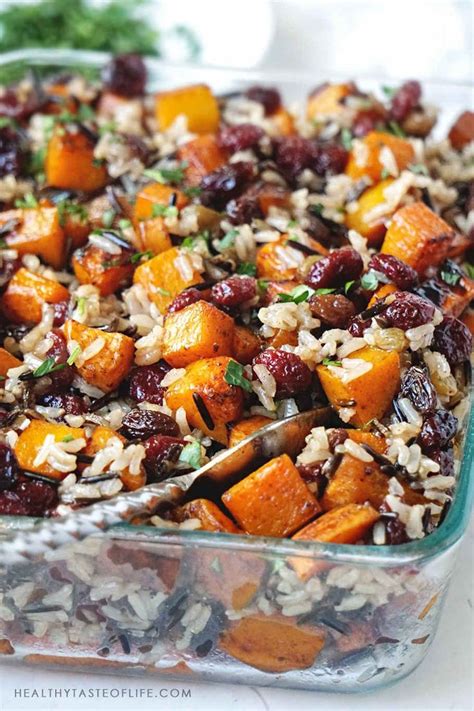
[64,321,135,393]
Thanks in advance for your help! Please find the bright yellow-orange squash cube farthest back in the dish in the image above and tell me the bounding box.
[155,84,220,133]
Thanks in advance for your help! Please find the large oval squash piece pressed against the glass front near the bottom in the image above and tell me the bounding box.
[219,615,325,673]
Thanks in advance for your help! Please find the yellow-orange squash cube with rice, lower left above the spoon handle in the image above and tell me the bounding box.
[14,420,86,479]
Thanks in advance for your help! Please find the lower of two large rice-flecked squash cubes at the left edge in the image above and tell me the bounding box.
[1,267,69,324]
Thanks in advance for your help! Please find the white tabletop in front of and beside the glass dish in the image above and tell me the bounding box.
[0,526,474,711]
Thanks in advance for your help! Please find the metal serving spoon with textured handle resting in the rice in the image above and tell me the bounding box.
[0,407,334,566]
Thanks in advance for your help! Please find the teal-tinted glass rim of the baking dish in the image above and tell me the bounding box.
[0,49,474,566]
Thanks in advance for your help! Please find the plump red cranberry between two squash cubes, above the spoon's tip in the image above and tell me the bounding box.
[253,348,311,398]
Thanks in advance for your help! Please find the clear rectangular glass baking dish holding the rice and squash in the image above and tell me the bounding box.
[0,52,474,692]
